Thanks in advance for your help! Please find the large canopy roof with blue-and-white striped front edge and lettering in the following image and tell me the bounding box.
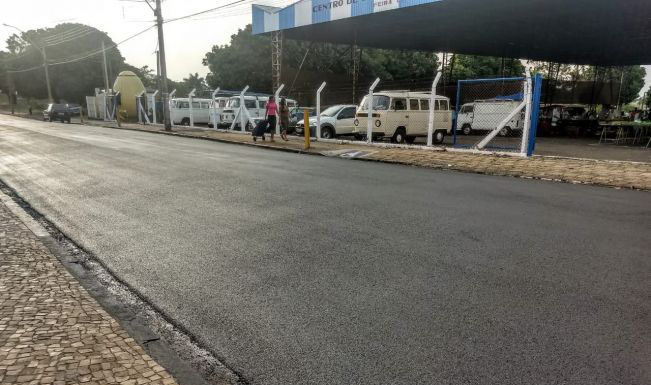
[253,0,651,66]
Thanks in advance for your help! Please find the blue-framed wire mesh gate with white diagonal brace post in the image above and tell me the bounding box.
[453,77,535,153]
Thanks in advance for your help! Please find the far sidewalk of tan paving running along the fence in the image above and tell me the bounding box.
[112,121,651,190]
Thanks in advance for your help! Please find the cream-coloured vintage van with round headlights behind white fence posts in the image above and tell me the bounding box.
[353,91,452,143]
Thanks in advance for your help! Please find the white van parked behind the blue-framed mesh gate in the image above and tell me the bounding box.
[457,99,524,136]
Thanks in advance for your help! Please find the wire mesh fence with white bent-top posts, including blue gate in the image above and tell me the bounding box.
[130,73,541,155]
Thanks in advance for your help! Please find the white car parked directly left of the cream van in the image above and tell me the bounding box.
[296,104,357,139]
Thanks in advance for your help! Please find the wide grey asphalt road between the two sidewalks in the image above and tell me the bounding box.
[0,116,651,385]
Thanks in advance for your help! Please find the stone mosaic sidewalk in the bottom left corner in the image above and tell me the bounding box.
[0,202,176,385]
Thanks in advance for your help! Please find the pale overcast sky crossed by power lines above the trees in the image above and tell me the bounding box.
[0,0,651,95]
